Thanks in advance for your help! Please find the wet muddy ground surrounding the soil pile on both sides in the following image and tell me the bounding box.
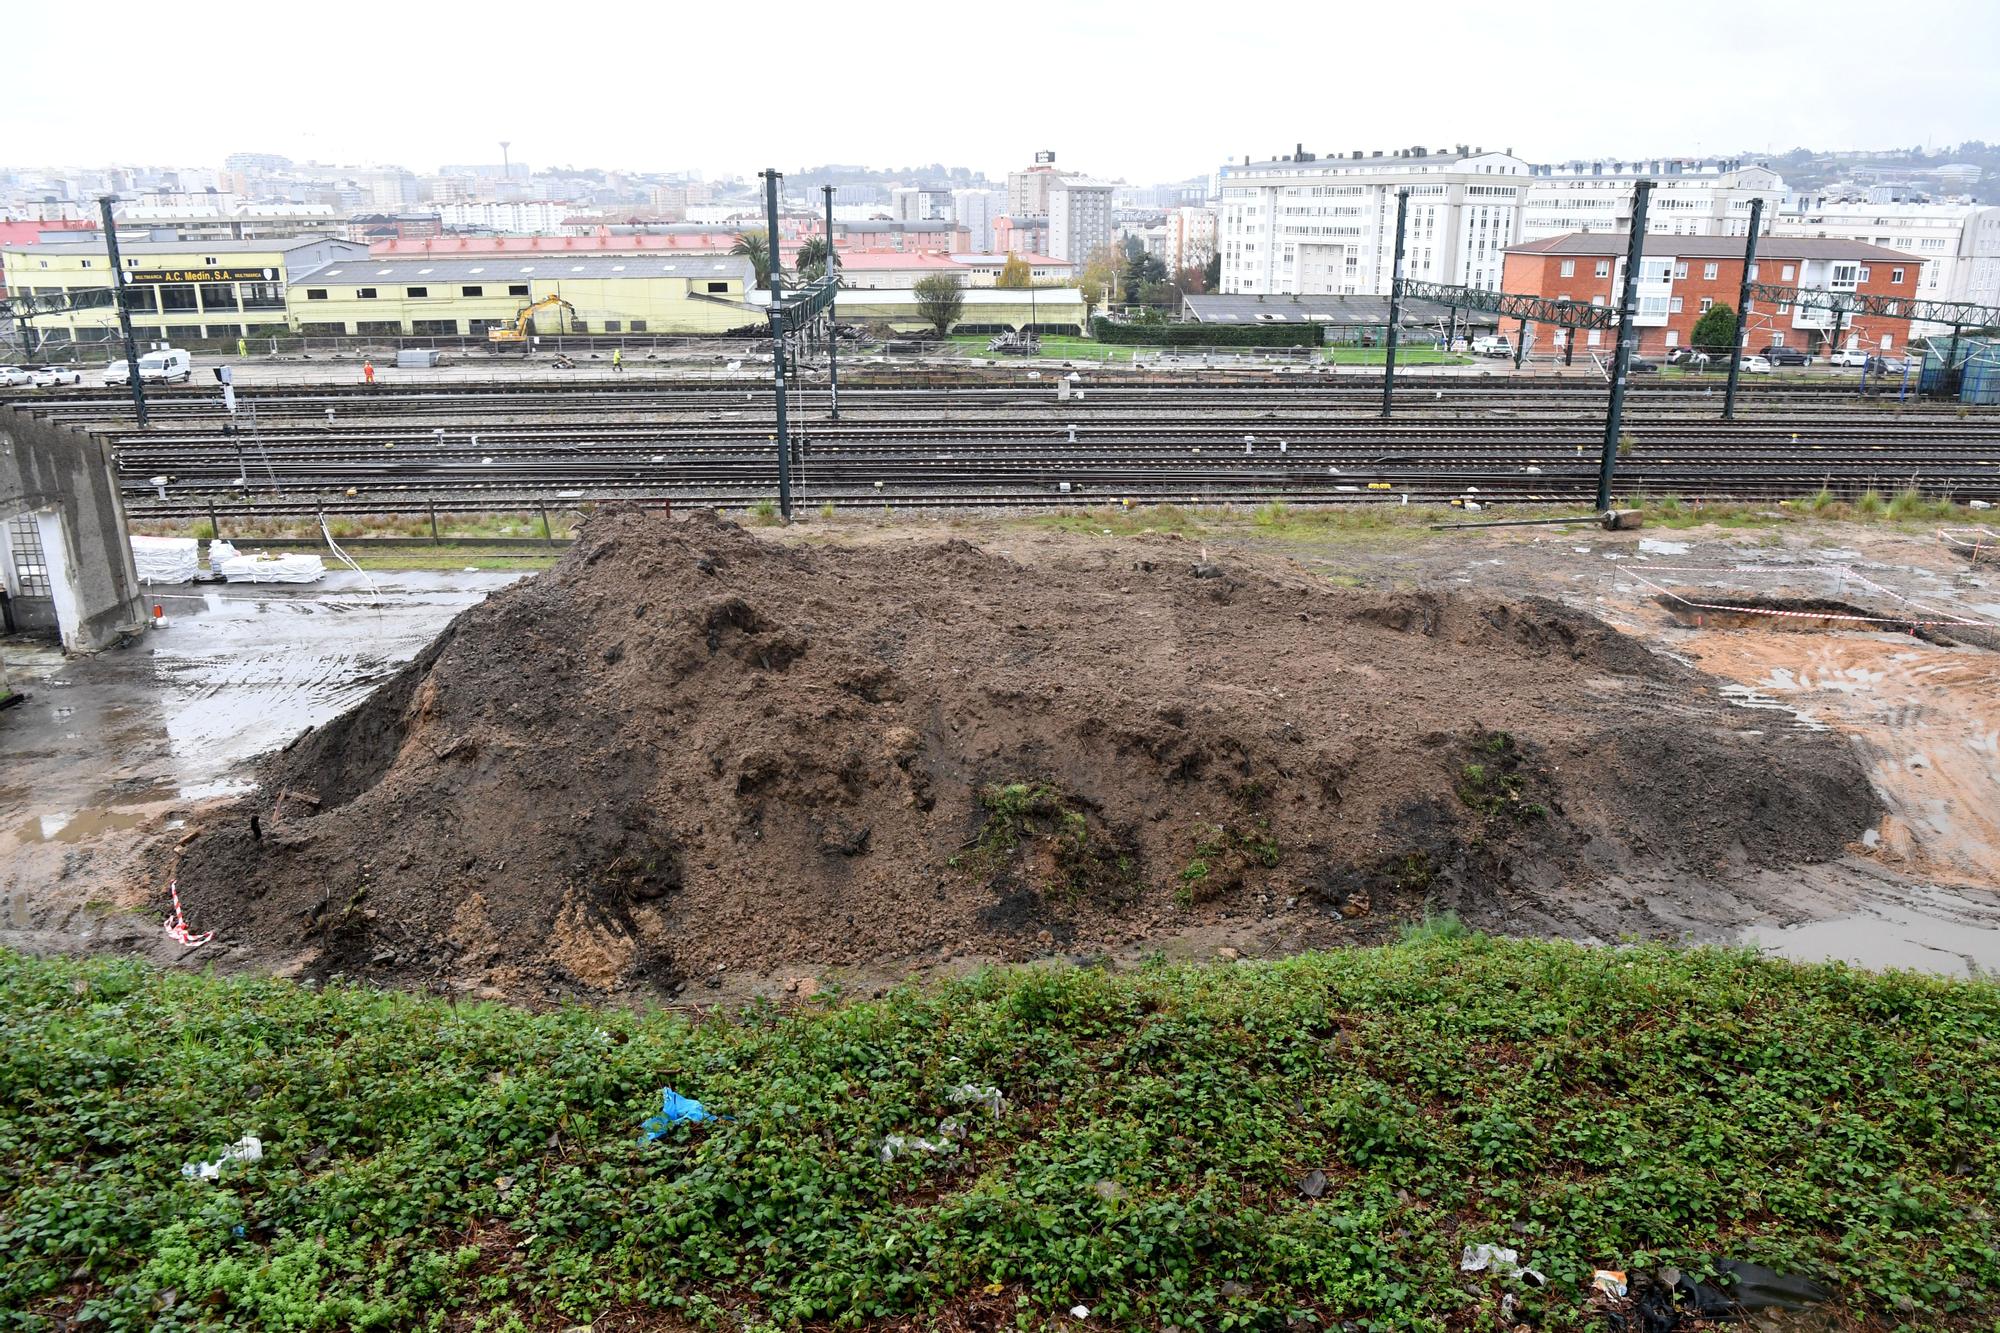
[0,522,2000,980]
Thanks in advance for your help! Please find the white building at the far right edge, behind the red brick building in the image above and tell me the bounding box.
[1766,194,2000,318]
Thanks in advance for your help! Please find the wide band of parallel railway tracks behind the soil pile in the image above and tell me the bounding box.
[11,370,2000,516]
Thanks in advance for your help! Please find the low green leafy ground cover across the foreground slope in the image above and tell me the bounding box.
[0,940,2000,1331]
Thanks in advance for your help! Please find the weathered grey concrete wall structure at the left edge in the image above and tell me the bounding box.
[0,408,146,652]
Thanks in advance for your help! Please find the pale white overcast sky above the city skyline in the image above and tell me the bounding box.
[15,0,2000,182]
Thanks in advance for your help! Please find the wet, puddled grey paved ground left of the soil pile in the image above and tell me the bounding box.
[0,572,518,955]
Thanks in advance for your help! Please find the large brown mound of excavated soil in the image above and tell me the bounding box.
[176,506,1878,993]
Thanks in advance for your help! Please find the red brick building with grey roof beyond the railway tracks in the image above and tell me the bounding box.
[1500,232,1924,356]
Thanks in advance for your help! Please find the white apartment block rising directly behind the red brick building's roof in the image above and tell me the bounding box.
[1520,158,1784,240]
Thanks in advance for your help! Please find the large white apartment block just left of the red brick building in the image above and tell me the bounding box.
[1216,144,1530,296]
